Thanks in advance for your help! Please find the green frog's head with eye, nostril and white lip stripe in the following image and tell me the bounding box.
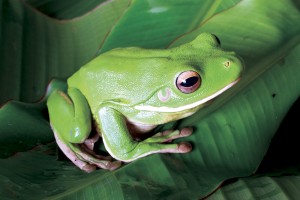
[135,33,244,123]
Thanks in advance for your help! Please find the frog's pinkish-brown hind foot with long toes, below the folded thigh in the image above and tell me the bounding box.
[54,133,122,172]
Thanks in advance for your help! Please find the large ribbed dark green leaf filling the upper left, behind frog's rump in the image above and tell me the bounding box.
[0,0,128,103]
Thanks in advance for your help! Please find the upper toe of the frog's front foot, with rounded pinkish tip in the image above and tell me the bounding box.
[144,128,193,143]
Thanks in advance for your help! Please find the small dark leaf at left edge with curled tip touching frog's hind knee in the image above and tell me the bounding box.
[0,80,67,158]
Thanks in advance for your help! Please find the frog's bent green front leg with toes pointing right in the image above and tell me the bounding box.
[98,106,192,162]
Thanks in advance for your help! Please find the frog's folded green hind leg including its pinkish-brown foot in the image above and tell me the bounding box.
[47,88,121,172]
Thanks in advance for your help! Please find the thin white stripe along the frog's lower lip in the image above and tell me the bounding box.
[134,79,240,113]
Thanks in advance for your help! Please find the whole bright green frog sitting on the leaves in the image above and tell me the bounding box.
[47,33,243,172]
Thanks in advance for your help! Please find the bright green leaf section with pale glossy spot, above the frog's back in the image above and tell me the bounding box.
[101,0,239,52]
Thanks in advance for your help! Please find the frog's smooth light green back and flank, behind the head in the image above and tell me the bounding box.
[68,48,172,110]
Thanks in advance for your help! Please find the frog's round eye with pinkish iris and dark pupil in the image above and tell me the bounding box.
[176,71,201,94]
